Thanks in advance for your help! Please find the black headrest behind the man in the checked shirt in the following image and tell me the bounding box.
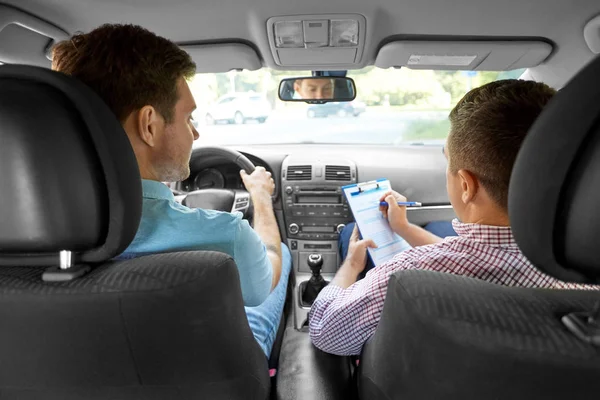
[508,58,600,282]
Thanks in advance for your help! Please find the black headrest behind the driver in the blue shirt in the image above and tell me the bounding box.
[0,65,142,266]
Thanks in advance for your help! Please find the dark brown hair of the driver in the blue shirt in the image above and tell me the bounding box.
[52,24,196,123]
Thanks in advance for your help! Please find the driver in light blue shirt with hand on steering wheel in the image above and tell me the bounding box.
[52,24,291,357]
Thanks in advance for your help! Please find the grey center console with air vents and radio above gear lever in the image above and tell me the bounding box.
[281,156,357,329]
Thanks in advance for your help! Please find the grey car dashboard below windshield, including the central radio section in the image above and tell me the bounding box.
[177,144,454,240]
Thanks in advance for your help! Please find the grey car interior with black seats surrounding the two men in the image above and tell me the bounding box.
[0,0,600,400]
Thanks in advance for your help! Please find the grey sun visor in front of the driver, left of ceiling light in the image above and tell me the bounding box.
[180,43,262,73]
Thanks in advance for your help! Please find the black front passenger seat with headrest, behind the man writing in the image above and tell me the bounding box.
[358,54,600,400]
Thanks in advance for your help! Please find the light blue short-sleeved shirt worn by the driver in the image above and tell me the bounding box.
[118,179,273,307]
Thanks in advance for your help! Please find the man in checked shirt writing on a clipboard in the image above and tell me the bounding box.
[309,80,596,355]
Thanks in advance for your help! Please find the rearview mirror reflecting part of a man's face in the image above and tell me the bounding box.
[279,76,356,103]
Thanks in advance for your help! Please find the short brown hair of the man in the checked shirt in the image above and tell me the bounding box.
[447,79,556,209]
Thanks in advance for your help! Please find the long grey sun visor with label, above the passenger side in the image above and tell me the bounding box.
[375,41,552,71]
